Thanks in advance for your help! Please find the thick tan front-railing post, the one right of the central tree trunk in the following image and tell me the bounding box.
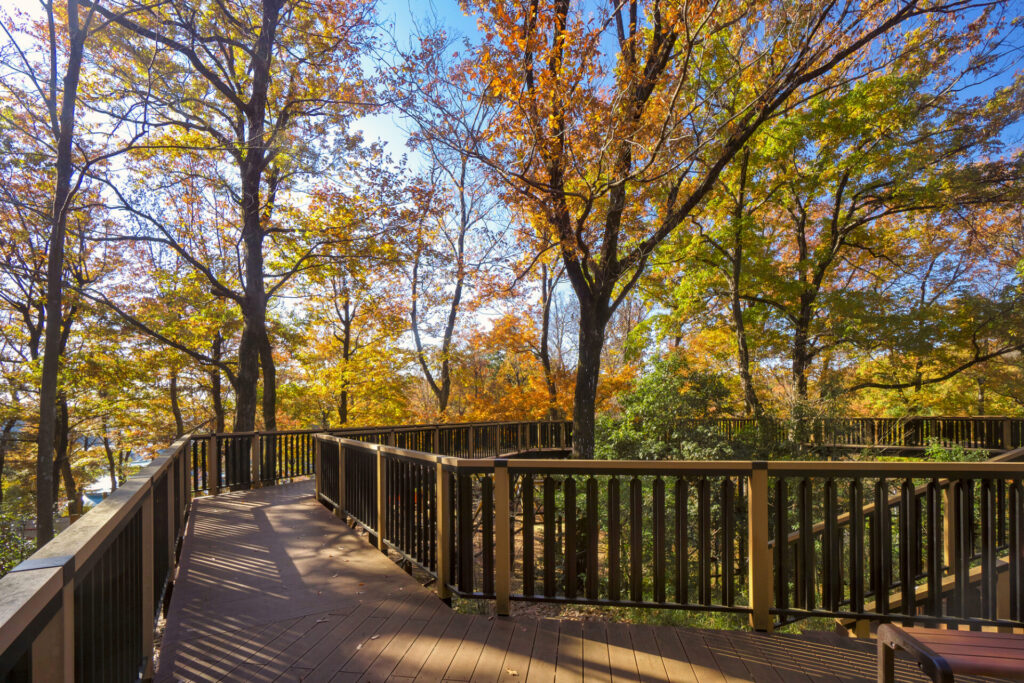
[746,461,772,631]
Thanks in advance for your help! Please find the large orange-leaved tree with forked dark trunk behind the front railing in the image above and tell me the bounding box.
[450,0,1015,458]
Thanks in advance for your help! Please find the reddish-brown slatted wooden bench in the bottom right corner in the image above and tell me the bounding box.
[878,624,1024,683]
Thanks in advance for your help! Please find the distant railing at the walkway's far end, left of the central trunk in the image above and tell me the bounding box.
[191,421,572,494]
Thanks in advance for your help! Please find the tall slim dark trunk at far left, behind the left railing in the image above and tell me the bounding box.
[36,0,88,546]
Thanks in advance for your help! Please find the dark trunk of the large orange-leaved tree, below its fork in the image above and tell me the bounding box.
[572,300,610,460]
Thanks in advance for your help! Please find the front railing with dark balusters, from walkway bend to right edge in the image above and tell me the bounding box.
[316,435,1024,629]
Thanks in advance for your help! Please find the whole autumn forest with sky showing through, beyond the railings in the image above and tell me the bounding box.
[0,0,1024,553]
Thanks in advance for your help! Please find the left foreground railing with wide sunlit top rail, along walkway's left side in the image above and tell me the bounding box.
[0,436,191,681]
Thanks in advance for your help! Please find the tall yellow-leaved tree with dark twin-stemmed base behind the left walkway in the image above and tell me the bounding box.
[89,0,374,431]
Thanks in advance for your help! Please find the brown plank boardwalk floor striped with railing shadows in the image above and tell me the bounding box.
[156,482,983,683]
